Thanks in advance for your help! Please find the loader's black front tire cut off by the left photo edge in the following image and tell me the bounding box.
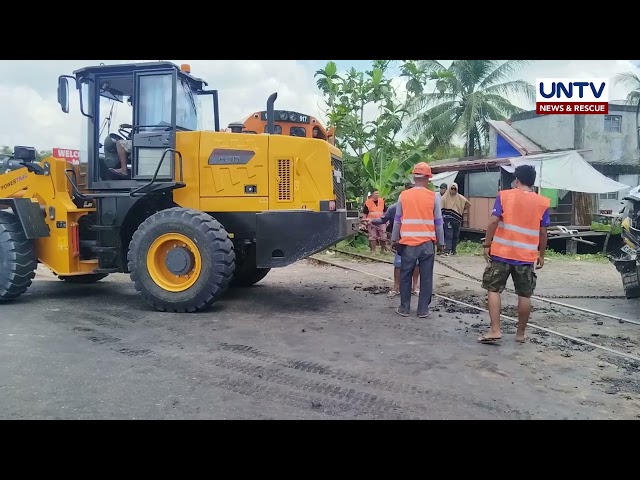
[0,212,38,302]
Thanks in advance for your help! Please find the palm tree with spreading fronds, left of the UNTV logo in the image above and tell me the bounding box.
[407,60,535,156]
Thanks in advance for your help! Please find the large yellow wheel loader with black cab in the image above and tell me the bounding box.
[0,62,358,312]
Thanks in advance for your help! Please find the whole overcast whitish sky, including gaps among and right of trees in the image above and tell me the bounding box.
[0,60,640,150]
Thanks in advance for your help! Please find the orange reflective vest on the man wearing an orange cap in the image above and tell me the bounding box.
[399,187,436,246]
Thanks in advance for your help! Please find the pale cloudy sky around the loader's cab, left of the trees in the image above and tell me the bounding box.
[0,60,322,150]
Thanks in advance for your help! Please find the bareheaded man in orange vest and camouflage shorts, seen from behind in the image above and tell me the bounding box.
[478,165,550,343]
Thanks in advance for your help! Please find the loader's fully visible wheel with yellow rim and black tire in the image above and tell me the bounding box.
[127,207,236,313]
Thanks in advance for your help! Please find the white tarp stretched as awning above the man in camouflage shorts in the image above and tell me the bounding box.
[502,150,630,193]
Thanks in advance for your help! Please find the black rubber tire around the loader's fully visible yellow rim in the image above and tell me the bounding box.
[127,207,236,313]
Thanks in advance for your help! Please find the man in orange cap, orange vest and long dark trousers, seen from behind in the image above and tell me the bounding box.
[391,162,444,318]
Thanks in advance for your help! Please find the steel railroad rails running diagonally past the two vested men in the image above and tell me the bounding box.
[309,250,640,365]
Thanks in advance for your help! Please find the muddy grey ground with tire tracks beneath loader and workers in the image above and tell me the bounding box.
[0,255,640,419]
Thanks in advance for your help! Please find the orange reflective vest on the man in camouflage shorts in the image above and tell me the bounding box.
[491,188,550,263]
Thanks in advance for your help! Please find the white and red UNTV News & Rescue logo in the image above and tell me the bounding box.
[536,78,609,115]
